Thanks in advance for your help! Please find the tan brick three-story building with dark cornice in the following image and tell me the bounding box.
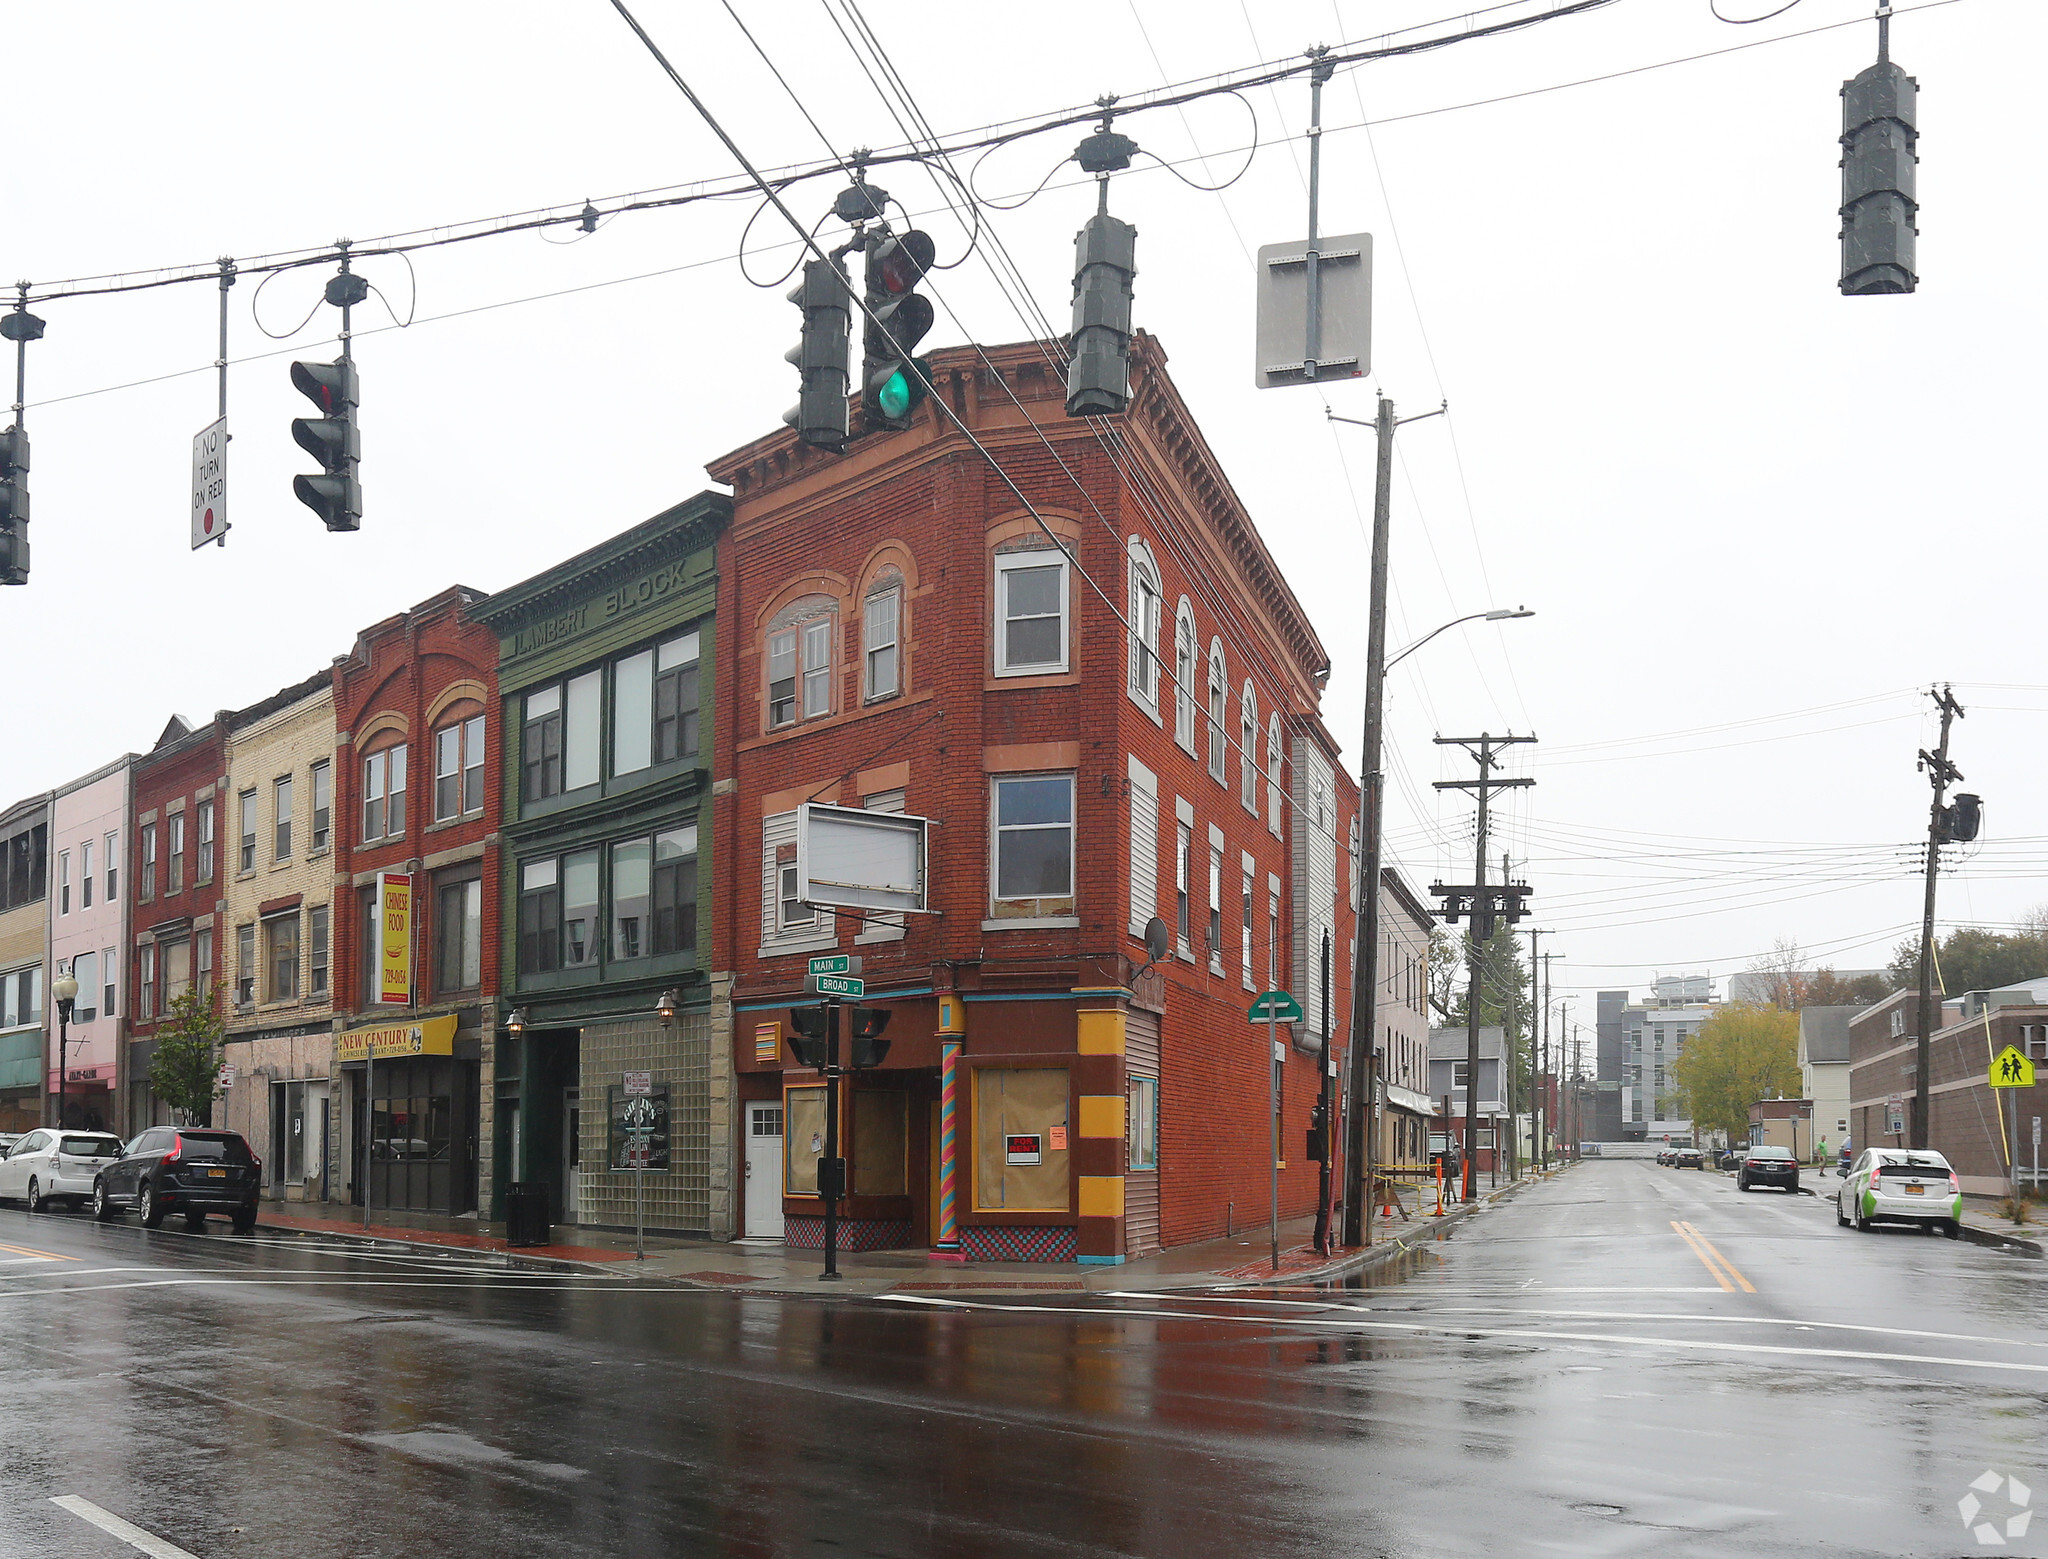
[213,670,342,1200]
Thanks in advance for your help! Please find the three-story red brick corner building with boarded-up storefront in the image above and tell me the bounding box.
[711,336,1356,1262]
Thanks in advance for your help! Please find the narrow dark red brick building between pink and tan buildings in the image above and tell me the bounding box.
[119,711,227,1133]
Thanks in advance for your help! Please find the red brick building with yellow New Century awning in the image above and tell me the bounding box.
[334,586,504,1213]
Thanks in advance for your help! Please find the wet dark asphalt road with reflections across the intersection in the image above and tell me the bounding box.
[0,1162,2048,1559]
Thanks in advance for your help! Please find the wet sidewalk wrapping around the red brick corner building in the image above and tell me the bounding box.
[258,1176,1534,1297]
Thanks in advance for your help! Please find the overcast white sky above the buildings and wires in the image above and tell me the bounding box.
[0,0,2048,1007]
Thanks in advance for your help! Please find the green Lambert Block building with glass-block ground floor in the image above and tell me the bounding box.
[473,492,733,1237]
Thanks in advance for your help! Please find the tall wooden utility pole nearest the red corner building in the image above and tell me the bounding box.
[1329,395,1444,1246]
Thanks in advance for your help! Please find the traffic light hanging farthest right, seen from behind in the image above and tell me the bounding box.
[1841,52,1919,297]
